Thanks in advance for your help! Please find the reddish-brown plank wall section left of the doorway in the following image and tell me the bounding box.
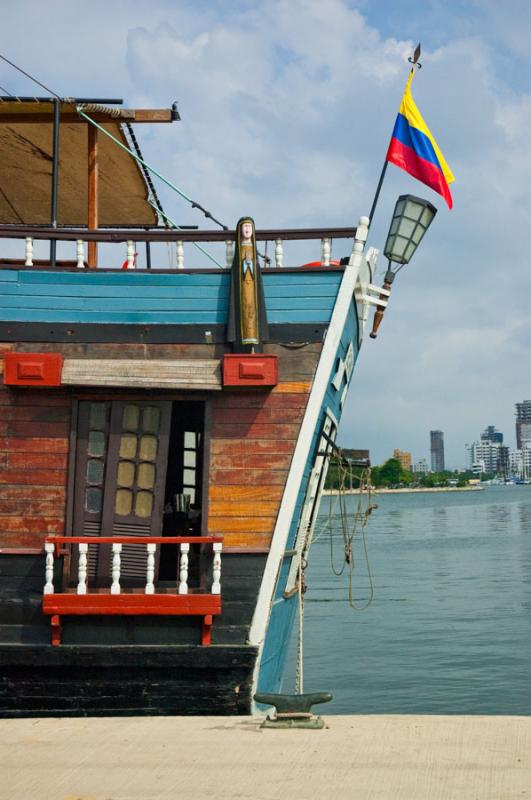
[0,344,71,548]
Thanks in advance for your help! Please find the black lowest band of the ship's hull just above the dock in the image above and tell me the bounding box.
[0,645,257,718]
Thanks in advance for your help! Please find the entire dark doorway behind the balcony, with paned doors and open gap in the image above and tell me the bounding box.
[71,398,204,587]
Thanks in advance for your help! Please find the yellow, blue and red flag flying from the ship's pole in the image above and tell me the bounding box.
[386,70,454,208]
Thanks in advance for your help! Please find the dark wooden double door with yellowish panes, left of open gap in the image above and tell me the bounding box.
[74,400,172,585]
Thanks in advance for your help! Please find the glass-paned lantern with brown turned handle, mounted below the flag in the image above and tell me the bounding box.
[370,194,437,339]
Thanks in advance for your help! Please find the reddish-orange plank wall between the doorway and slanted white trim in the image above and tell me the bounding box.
[208,343,321,552]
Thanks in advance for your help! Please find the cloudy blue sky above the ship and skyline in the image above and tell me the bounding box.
[0,0,531,468]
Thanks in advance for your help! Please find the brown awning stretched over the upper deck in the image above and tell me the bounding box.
[0,101,160,227]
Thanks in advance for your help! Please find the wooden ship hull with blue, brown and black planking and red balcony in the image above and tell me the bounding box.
[0,97,374,717]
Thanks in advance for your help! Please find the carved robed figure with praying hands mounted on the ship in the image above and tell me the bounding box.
[227,217,268,353]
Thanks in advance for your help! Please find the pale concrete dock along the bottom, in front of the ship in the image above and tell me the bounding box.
[0,716,531,800]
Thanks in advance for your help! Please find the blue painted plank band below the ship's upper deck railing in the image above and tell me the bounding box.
[0,270,342,325]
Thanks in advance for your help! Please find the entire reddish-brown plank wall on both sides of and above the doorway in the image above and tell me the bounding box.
[0,343,321,553]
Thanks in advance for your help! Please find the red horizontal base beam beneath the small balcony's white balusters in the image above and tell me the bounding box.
[42,594,221,616]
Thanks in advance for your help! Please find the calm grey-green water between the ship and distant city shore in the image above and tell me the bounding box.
[284,486,531,714]
